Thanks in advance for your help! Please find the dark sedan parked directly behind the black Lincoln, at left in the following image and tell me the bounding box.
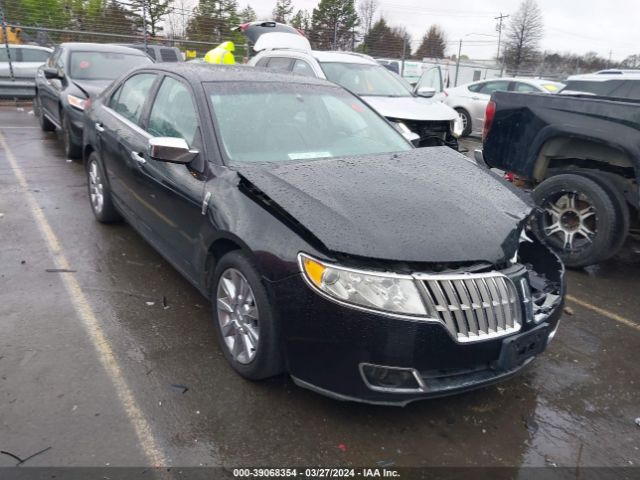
[33,43,153,158]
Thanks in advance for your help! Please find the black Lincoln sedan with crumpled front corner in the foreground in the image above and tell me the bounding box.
[84,64,564,405]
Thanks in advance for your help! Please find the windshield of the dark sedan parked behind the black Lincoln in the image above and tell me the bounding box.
[69,52,153,80]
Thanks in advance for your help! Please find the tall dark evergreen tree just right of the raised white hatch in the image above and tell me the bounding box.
[309,0,360,50]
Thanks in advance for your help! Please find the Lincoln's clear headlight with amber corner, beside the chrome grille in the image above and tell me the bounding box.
[298,253,427,316]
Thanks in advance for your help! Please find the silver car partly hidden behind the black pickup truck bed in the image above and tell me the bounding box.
[437,78,564,136]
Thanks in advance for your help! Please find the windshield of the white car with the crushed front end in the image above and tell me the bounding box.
[321,62,413,97]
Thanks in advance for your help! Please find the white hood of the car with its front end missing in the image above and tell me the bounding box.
[361,96,458,121]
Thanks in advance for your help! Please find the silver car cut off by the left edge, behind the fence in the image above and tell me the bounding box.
[0,45,52,98]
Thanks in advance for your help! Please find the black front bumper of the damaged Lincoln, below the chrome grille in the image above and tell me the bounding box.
[271,275,562,405]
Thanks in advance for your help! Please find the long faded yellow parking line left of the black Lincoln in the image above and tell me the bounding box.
[0,133,168,466]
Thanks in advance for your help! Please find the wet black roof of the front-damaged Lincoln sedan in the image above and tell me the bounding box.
[134,62,341,88]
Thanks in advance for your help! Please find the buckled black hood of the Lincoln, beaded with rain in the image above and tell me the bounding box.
[237,147,532,263]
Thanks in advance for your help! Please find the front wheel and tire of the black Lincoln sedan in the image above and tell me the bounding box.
[212,250,283,380]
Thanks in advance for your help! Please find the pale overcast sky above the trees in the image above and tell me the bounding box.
[248,0,640,60]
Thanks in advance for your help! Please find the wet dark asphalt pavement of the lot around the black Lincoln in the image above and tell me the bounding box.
[0,106,640,467]
